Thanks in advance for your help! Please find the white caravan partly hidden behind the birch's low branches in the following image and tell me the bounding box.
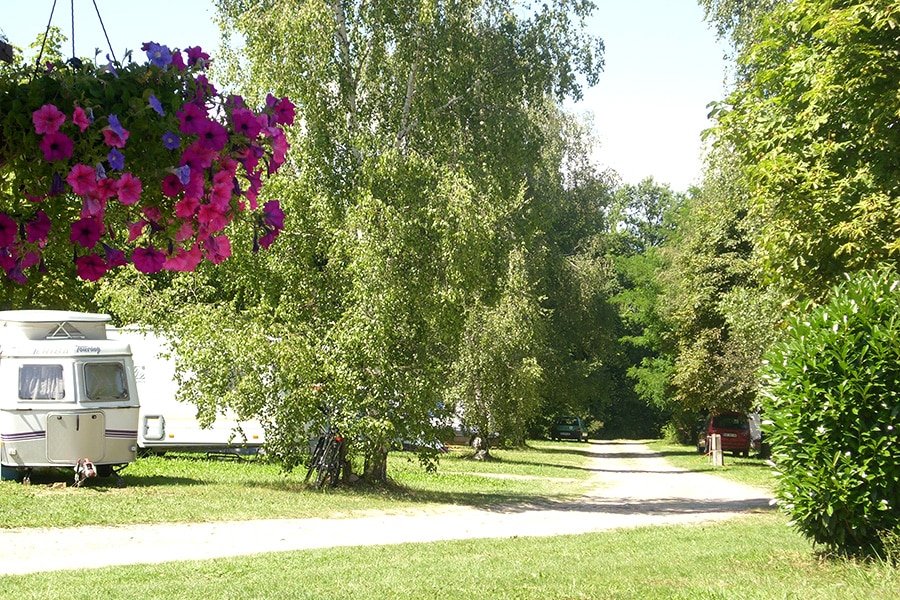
[107,327,265,454]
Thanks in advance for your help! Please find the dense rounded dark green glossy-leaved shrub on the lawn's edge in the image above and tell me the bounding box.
[763,269,900,554]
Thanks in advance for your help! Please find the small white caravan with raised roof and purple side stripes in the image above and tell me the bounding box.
[0,310,138,485]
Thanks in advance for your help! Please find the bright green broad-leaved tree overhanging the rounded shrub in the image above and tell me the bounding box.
[715,0,900,298]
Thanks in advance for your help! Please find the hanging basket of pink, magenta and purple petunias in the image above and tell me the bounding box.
[0,43,294,283]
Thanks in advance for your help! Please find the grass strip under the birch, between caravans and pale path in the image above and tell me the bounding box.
[0,442,590,528]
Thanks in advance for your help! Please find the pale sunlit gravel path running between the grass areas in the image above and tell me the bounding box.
[0,441,770,574]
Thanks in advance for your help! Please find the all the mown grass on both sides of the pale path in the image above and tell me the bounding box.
[0,442,900,600]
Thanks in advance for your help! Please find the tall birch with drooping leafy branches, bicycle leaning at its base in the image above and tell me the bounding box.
[105,0,602,480]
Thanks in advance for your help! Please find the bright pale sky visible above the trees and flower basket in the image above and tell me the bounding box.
[0,0,725,191]
